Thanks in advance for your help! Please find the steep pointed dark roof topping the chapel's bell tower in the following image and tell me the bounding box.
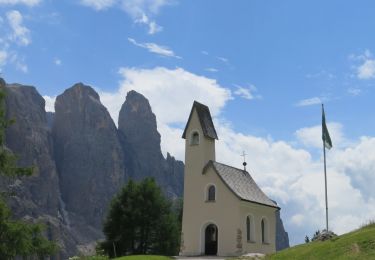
[182,101,218,139]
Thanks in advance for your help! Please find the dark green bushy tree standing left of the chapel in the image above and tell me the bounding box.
[99,178,180,257]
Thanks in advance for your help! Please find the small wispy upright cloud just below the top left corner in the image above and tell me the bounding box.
[6,10,31,46]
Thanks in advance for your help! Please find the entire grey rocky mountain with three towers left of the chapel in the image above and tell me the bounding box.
[0,78,184,259]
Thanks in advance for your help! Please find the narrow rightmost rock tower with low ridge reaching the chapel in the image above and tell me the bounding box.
[118,91,183,197]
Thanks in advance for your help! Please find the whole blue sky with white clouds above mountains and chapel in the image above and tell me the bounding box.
[0,0,375,247]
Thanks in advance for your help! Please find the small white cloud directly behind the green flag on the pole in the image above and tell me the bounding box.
[295,122,349,148]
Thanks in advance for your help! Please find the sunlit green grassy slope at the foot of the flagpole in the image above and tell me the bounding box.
[266,223,375,260]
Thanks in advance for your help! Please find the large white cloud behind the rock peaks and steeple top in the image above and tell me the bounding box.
[101,67,231,124]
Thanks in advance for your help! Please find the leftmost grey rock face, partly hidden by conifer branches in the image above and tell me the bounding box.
[0,81,76,259]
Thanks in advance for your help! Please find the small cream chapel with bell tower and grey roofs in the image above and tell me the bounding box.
[180,101,280,256]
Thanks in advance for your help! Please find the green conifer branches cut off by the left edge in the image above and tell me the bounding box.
[0,84,58,259]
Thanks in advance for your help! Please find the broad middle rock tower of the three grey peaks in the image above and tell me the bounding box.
[52,83,125,230]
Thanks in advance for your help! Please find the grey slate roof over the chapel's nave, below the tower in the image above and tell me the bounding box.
[203,161,279,208]
